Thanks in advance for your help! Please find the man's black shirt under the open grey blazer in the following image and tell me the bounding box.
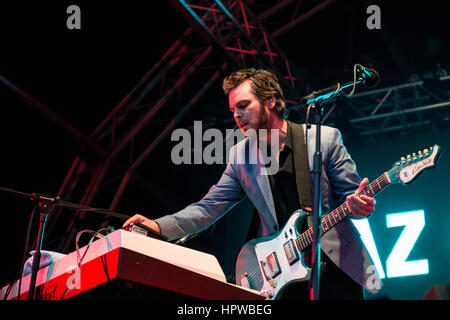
[268,122,303,229]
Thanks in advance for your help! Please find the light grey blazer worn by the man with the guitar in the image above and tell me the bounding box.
[155,122,381,293]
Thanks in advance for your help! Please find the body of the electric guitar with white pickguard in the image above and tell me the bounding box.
[236,210,310,299]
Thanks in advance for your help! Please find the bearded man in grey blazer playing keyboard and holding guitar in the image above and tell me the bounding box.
[124,68,375,299]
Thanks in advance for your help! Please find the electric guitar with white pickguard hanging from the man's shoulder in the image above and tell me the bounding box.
[235,145,441,300]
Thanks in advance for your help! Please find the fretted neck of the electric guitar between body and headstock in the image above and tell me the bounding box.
[296,172,391,250]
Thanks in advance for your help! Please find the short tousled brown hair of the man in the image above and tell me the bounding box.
[222,68,288,119]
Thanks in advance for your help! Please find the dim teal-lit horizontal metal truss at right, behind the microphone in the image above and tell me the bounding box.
[324,76,450,137]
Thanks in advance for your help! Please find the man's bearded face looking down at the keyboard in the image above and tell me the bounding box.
[228,81,268,134]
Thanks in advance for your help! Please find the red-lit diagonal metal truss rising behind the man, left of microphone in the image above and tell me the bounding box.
[3,0,334,252]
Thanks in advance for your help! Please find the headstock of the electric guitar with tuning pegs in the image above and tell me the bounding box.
[387,144,441,184]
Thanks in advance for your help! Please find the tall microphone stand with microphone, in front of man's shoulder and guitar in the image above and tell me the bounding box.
[301,64,379,300]
